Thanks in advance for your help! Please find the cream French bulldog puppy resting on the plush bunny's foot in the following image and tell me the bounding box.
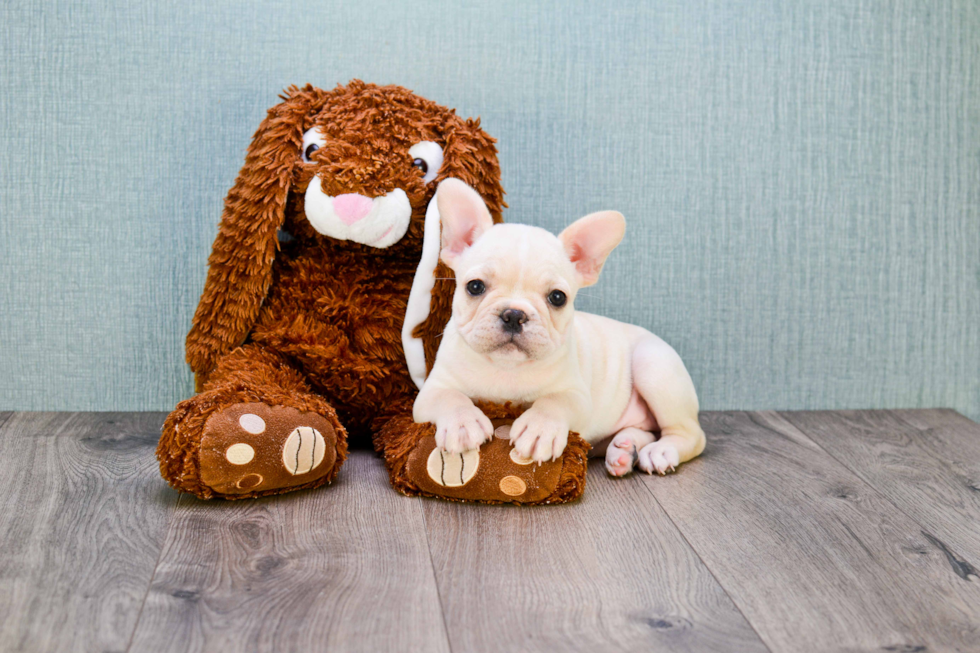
[414,179,705,476]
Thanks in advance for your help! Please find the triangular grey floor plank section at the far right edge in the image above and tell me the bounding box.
[783,410,980,568]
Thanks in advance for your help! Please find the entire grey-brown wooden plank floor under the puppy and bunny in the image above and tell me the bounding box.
[0,410,980,653]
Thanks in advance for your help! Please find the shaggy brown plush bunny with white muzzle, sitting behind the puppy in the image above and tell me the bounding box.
[157,80,587,503]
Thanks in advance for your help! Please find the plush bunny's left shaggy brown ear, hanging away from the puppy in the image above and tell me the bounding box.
[187,85,327,390]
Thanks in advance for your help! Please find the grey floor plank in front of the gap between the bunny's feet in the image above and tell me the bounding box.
[132,451,449,652]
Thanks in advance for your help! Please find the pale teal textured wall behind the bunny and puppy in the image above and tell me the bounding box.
[0,0,980,418]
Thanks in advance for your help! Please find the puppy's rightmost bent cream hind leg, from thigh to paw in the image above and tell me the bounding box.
[632,336,705,474]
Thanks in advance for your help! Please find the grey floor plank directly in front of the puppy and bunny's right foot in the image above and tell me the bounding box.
[423,462,766,653]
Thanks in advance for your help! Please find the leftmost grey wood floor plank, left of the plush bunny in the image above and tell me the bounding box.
[0,413,177,652]
